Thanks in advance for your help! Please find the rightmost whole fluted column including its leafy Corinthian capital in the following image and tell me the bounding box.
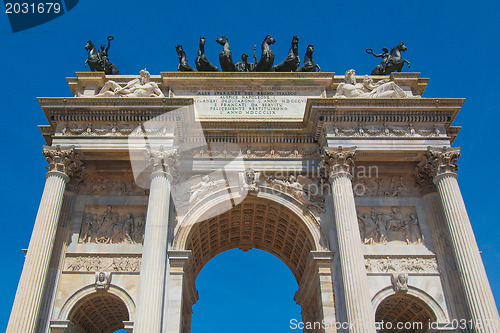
[420,147,500,332]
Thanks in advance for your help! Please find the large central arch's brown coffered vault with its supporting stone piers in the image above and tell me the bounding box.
[169,196,335,333]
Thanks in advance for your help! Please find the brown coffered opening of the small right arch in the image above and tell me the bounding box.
[375,293,437,333]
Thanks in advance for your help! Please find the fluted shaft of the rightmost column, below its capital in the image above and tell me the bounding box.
[435,173,500,332]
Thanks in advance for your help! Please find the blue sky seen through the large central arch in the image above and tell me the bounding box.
[191,249,302,333]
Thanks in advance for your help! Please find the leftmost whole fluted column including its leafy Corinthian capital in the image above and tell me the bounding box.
[7,146,82,333]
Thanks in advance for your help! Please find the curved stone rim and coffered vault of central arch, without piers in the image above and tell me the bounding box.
[172,187,328,282]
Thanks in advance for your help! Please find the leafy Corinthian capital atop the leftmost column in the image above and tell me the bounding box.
[43,145,83,180]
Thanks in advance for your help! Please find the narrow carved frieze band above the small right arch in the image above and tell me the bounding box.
[365,256,438,274]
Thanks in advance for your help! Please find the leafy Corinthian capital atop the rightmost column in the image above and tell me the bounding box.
[417,146,460,183]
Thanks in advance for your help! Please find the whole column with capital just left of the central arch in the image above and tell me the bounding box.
[134,146,177,333]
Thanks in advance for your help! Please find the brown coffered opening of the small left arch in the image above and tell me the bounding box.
[68,292,130,333]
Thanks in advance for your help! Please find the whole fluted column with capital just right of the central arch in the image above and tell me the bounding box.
[322,147,375,333]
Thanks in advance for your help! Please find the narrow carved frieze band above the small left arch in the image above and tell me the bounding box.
[63,254,141,272]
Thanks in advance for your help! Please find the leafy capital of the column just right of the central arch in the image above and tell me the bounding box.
[320,146,356,179]
